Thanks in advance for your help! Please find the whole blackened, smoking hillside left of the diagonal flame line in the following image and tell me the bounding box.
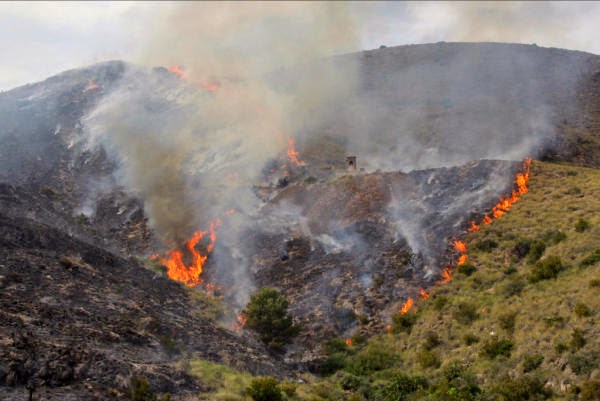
[0,43,600,399]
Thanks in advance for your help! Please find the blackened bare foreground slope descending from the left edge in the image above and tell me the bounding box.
[0,213,285,400]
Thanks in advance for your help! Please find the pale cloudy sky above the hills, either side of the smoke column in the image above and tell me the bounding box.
[0,1,600,91]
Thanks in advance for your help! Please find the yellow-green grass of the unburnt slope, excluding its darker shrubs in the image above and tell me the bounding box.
[184,162,600,400]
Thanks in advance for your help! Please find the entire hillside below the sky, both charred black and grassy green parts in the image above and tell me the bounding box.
[0,43,600,400]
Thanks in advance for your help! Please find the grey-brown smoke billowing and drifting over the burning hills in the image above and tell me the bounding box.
[85,3,592,306]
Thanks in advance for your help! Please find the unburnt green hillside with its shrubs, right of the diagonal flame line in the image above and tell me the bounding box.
[170,162,600,400]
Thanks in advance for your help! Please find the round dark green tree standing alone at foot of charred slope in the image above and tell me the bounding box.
[246,288,300,349]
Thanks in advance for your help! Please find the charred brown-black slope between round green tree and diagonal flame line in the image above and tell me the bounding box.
[237,160,520,360]
